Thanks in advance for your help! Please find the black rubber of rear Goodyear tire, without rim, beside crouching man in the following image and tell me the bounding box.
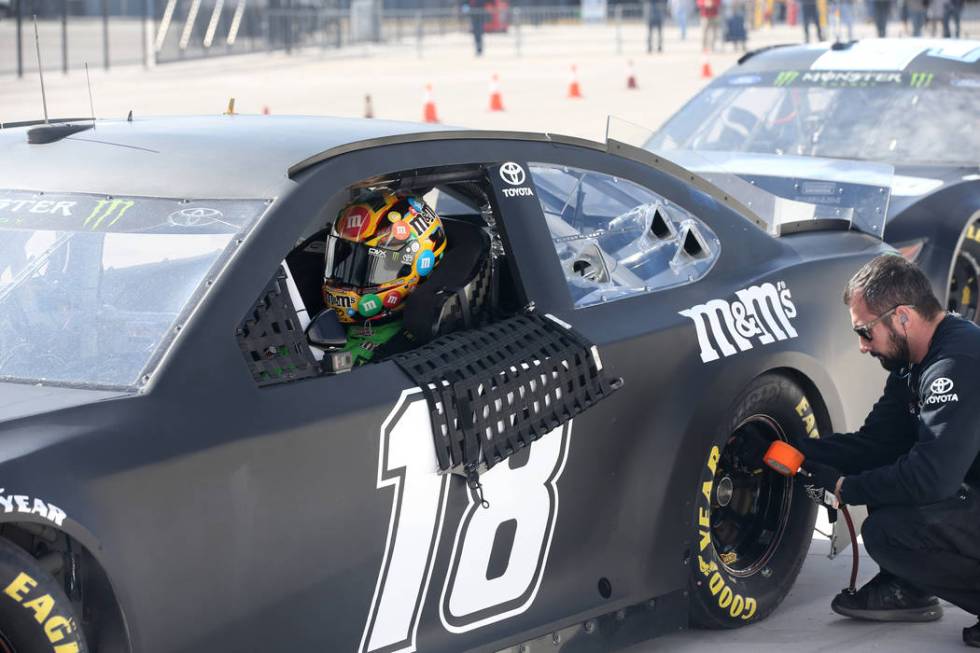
[691,374,819,628]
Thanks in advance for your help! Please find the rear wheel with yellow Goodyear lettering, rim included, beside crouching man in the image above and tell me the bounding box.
[690,374,819,628]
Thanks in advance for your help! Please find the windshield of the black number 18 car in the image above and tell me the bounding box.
[0,191,267,388]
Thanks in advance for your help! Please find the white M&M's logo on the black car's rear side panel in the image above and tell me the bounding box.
[680,281,798,363]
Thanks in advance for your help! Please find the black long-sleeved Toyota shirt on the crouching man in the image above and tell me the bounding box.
[840,315,980,505]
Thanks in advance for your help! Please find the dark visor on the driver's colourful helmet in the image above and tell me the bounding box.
[323,236,413,288]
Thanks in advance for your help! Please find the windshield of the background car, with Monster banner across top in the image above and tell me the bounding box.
[646,70,980,165]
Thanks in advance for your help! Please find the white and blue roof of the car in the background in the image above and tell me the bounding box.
[726,38,980,75]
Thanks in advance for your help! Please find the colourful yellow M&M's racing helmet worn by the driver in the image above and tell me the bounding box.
[323,190,446,324]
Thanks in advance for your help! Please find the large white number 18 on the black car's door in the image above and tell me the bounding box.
[358,390,571,653]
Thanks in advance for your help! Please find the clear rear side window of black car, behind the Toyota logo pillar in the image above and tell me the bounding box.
[530,163,720,308]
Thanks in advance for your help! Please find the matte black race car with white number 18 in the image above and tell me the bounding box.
[0,116,887,653]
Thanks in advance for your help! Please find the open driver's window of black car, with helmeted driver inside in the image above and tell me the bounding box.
[239,164,523,385]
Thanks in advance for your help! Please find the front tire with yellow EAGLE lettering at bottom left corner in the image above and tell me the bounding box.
[0,540,88,653]
